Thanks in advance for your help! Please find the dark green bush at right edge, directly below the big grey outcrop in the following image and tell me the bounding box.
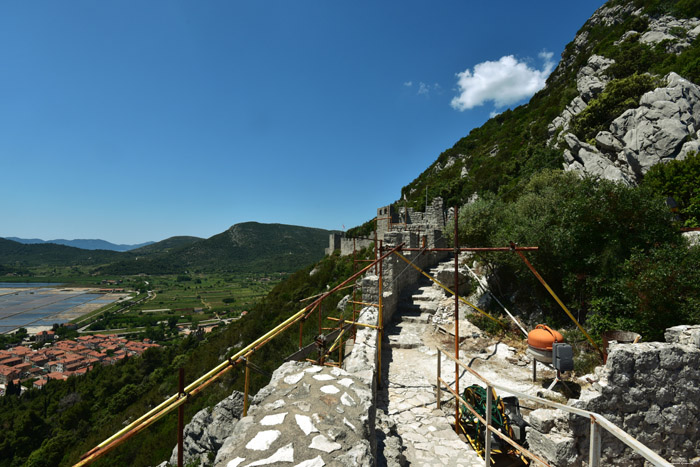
[643,153,700,227]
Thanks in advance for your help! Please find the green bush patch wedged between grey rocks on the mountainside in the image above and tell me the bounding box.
[570,74,660,141]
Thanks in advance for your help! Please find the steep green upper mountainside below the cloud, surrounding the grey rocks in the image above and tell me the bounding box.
[399,0,700,210]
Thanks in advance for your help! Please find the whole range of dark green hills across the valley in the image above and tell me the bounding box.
[0,222,331,274]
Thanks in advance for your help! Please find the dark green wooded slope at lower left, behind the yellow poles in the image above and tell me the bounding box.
[0,250,366,467]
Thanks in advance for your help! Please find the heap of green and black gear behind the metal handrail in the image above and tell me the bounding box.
[459,384,528,464]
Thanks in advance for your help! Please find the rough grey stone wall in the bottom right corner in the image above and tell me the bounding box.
[527,326,700,466]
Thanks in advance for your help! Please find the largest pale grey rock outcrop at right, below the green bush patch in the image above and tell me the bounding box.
[563,73,700,184]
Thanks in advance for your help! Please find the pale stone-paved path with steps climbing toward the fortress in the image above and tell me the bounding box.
[377,258,537,467]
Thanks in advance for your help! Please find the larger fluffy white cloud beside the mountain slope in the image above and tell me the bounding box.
[450,51,554,111]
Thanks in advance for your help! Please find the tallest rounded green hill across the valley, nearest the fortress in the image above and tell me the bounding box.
[99,222,331,274]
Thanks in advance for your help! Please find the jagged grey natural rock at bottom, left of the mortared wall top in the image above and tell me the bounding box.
[170,391,243,465]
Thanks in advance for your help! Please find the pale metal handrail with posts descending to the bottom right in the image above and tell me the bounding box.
[437,347,673,467]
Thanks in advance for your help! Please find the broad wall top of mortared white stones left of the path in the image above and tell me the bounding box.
[214,362,376,467]
